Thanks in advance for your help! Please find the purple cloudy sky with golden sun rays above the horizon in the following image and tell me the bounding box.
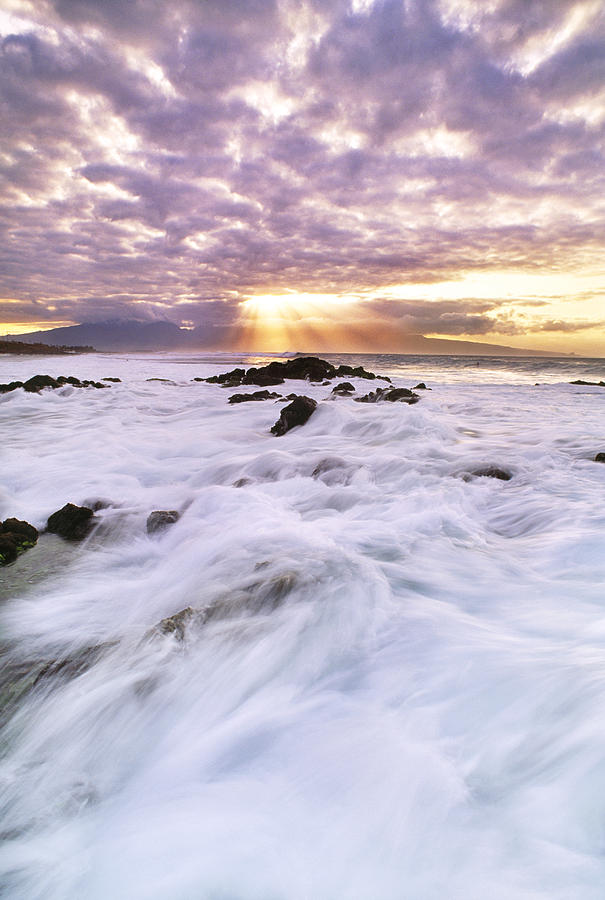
[0,0,605,356]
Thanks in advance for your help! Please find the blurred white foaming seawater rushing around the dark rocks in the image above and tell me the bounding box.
[0,354,605,900]
